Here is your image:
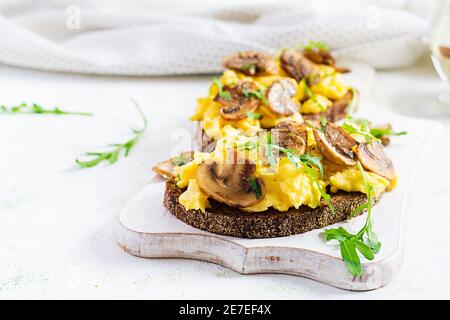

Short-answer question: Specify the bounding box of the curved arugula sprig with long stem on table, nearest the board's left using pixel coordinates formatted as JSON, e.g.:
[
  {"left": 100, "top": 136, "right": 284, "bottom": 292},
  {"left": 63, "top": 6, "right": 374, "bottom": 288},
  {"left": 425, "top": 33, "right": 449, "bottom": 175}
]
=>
[{"left": 76, "top": 99, "right": 147, "bottom": 168}]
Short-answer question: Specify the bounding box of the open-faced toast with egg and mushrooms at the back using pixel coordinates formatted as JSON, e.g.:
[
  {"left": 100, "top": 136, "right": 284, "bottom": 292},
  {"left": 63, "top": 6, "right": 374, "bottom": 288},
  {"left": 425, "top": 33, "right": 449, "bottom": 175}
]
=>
[{"left": 191, "top": 42, "right": 356, "bottom": 150}]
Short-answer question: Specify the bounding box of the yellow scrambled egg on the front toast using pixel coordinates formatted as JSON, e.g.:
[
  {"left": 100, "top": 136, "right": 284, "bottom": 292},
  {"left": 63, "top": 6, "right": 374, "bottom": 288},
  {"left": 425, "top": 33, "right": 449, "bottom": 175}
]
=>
[{"left": 175, "top": 132, "right": 396, "bottom": 212}]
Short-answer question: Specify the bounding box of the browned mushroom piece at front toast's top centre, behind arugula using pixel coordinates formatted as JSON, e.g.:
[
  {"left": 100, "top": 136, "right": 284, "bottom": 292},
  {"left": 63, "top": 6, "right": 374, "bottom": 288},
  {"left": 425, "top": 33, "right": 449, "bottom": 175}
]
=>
[{"left": 272, "top": 121, "right": 308, "bottom": 155}]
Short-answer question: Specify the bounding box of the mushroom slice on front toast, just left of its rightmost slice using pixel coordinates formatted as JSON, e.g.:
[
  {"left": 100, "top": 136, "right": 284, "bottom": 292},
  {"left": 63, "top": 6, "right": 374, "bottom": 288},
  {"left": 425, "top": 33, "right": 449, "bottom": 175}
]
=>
[{"left": 313, "top": 123, "right": 357, "bottom": 166}]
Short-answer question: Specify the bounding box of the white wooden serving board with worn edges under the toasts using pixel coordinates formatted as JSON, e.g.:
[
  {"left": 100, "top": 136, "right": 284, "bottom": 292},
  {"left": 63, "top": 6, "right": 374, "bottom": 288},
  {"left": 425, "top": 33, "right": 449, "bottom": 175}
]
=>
[{"left": 115, "top": 62, "right": 440, "bottom": 291}]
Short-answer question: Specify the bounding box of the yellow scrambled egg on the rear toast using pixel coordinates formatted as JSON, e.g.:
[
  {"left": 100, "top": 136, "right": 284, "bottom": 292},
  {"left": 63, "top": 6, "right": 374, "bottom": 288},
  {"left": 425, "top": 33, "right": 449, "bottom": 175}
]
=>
[{"left": 190, "top": 65, "right": 350, "bottom": 140}]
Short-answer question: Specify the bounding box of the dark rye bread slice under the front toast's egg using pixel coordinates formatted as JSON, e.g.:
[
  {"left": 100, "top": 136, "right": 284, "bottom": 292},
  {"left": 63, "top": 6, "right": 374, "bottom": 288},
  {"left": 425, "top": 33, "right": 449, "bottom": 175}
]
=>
[{"left": 164, "top": 181, "right": 378, "bottom": 239}]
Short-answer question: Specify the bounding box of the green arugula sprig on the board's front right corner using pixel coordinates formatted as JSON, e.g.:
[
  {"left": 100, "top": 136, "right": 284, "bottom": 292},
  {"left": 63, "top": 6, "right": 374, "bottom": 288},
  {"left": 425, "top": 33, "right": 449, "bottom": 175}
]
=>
[{"left": 324, "top": 162, "right": 381, "bottom": 277}]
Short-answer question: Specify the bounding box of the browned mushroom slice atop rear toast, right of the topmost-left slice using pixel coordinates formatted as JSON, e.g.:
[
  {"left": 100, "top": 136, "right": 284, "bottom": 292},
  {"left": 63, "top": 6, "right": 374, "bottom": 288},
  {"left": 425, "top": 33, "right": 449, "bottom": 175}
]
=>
[{"left": 280, "top": 49, "right": 319, "bottom": 84}]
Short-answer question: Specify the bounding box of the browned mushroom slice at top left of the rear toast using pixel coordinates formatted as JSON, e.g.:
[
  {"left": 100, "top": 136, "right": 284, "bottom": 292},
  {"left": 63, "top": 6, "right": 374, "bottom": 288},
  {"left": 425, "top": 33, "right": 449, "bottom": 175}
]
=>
[{"left": 223, "top": 51, "right": 278, "bottom": 76}]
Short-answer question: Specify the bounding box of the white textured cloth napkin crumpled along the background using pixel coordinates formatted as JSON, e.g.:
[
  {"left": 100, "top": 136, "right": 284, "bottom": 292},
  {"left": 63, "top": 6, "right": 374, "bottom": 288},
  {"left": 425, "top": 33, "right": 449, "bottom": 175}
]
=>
[{"left": 0, "top": 0, "right": 428, "bottom": 75}]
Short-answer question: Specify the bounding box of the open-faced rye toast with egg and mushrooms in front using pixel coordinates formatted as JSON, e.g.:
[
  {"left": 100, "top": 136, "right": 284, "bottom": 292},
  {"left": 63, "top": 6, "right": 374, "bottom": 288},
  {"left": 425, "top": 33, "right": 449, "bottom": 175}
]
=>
[{"left": 154, "top": 118, "right": 396, "bottom": 238}]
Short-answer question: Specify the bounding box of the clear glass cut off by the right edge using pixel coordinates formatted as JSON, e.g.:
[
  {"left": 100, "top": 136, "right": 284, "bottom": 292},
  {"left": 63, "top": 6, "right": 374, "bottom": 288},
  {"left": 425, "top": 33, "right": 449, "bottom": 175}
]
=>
[{"left": 430, "top": 0, "right": 450, "bottom": 109}]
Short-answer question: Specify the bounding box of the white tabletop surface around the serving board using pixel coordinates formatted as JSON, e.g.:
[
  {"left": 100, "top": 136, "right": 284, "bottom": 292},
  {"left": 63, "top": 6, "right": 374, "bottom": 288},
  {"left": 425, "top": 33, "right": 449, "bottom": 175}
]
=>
[{"left": 0, "top": 59, "right": 450, "bottom": 299}]
